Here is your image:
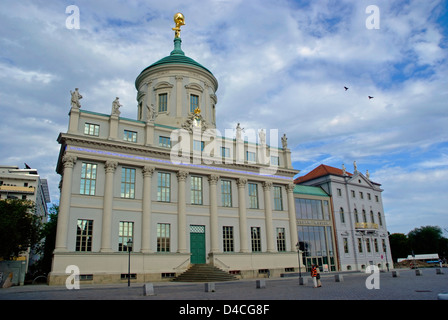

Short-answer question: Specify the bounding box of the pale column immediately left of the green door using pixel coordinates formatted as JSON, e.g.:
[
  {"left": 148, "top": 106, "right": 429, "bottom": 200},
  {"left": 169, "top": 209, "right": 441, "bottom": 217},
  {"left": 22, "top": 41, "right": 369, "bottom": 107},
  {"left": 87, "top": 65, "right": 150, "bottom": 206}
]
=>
[{"left": 176, "top": 171, "right": 188, "bottom": 253}]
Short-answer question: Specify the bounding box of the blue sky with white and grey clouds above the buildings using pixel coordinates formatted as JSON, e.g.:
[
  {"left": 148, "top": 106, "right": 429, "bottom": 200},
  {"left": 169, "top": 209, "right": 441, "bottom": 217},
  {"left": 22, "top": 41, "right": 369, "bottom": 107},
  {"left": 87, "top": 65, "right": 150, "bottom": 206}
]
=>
[{"left": 0, "top": 0, "right": 448, "bottom": 236}]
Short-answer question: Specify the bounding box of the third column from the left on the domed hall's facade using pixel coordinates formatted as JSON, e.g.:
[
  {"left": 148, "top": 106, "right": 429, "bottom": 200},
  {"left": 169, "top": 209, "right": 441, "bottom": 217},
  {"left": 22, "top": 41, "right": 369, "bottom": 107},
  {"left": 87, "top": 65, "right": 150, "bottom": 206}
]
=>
[{"left": 141, "top": 166, "right": 154, "bottom": 253}]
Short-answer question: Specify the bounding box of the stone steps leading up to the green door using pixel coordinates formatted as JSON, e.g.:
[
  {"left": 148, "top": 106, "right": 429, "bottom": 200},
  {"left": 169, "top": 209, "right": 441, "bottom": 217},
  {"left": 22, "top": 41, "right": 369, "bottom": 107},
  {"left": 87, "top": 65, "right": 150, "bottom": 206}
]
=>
[{"left": 173, "top": 264, "right": 238, "bottom": 282}]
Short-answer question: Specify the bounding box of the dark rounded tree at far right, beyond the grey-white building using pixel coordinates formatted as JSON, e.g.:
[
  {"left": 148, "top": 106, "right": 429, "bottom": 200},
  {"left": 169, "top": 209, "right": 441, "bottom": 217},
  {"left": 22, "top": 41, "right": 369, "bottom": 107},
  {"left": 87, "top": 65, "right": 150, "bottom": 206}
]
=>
[{"left": 408, "top": 226, "right": 444, "bottom": 254}]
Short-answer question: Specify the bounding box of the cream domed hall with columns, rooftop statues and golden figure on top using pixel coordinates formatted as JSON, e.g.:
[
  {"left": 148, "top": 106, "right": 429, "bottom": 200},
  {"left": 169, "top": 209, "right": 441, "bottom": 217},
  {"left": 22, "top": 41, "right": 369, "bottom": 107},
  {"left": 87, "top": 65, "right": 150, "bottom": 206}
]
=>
[{"left": 50, "top": 14, "right": 299, "bottom": 284}]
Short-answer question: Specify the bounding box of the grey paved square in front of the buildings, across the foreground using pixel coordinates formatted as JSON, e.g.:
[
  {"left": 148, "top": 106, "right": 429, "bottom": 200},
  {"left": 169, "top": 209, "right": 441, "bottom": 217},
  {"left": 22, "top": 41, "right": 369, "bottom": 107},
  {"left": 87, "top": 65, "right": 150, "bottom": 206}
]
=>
[{"left": 0, "top": 268, "right": 448, "bottom": 301}]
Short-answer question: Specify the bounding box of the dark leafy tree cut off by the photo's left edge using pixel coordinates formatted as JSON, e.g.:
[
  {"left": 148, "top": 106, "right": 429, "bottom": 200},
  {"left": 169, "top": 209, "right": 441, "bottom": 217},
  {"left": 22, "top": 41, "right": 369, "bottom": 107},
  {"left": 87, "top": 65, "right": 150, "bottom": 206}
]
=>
[{"left": 0, "top": 199, "right": 42, "bottom": 260}]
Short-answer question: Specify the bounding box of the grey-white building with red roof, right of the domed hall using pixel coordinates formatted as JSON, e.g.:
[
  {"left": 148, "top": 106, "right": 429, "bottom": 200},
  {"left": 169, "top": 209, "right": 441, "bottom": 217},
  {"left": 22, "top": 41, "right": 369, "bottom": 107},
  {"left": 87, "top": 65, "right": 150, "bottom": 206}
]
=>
[{"left": 295, "top": 163, "right": 393, "bottom": 271}]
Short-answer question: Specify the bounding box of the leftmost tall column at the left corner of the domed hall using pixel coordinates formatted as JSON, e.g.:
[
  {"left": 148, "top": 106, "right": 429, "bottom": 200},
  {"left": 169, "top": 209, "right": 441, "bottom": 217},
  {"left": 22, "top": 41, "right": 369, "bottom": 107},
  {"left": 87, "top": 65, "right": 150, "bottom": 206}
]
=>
[{"left": 54, "top": 154, "right": 76, "bottom": 252}]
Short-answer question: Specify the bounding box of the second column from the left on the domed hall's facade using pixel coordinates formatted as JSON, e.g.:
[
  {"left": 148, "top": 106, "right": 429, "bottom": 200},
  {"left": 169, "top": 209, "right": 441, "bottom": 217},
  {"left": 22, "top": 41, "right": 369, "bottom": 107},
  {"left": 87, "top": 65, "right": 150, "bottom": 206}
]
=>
[{"left": 100, "top": 161, "right": 118, "bottom": 252}]
